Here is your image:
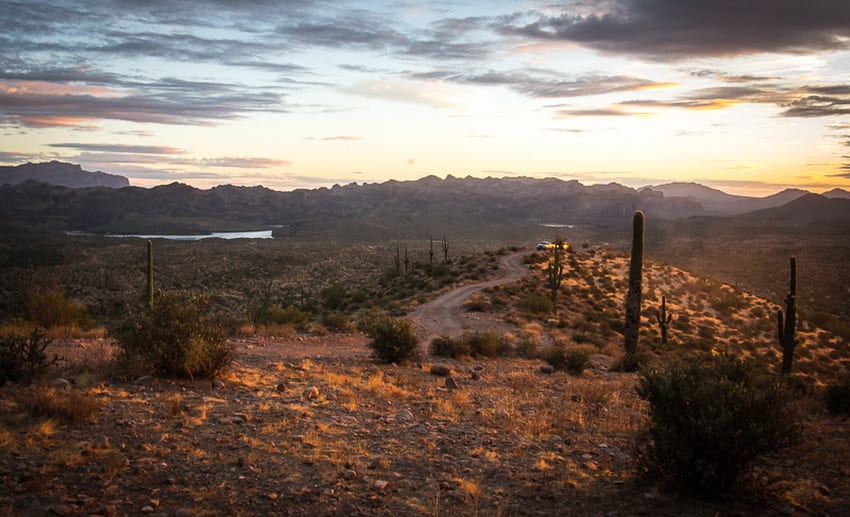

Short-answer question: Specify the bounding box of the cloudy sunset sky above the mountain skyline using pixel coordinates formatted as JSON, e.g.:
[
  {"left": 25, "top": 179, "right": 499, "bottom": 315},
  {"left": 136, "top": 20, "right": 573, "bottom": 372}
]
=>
[{"left": 0, "top": 0, "right": 850, "bottom": 195}]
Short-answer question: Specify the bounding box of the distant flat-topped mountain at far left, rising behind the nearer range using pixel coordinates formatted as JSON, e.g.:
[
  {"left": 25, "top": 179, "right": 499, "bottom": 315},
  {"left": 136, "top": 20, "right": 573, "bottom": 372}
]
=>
[{"left": 0, "top": 160, "right": 130, "bottom": 188}]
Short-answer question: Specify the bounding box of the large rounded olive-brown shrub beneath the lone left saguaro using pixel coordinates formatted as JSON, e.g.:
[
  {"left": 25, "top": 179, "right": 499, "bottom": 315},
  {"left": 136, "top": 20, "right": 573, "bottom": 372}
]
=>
[{"left": 111, "top": 292, "right": 233, "bottom": 378}]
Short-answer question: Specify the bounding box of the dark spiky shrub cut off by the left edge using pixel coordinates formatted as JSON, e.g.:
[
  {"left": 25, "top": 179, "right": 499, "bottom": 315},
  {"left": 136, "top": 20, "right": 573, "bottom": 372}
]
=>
[{"left": 0, "top": 331, "right": 59, "bottom": 383}]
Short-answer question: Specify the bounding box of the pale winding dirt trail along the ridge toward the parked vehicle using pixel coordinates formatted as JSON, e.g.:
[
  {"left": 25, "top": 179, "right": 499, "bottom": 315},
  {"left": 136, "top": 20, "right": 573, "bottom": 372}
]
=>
[{"left": 409, "top": 251, "right": 529, "bottom": 343}]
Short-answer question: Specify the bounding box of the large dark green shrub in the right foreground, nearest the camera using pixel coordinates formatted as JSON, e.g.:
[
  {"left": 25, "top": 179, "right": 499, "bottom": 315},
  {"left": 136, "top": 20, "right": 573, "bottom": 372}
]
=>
[{"left": 638, "top": 355, "right": 799, "bottom": 494}]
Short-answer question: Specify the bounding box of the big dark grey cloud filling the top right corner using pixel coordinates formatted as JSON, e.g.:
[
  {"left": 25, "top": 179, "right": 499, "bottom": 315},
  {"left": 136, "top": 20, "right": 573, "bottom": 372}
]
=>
[{"left": 501, "top": 0, "right": 850, "bottom": 60}]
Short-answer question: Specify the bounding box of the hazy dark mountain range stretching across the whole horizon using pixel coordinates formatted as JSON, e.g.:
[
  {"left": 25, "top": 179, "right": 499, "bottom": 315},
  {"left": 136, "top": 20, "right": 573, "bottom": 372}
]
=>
[{"left": 0, "top": 162, "right": 850, "bottom": 238}]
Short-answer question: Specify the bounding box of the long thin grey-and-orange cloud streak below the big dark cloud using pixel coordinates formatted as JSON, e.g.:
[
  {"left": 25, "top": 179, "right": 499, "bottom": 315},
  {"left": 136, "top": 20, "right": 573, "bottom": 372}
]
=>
[{"left": 412, "top": 70, "right": 672, "bottom": 98}]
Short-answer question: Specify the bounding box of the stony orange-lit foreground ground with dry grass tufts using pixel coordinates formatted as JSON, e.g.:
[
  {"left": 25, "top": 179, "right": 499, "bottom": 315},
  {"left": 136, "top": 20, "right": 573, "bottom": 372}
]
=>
[{"left": 0, "top": 335, "right": 850, "bottom": 516}]
